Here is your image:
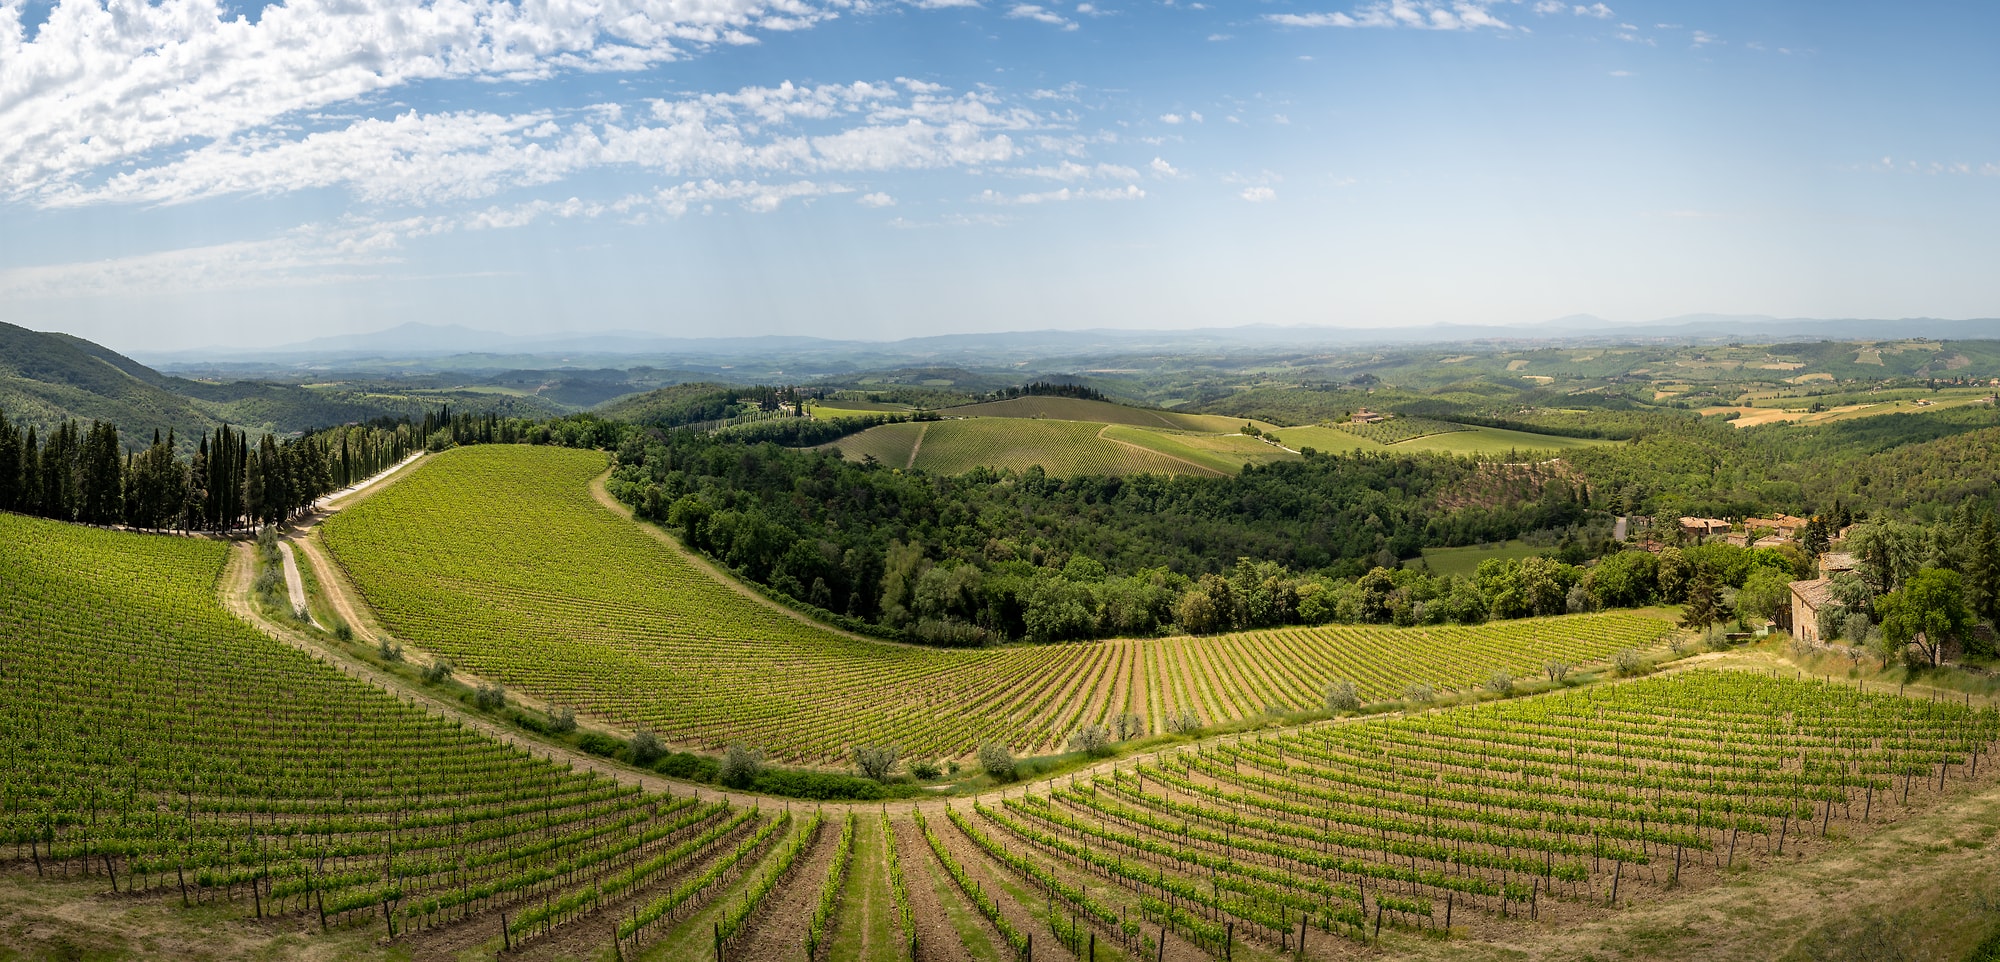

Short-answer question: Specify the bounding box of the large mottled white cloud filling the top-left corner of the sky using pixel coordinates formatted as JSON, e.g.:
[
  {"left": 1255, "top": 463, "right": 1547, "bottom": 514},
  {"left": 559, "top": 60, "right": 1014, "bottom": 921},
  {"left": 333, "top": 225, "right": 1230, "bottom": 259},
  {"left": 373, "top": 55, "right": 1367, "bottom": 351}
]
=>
[{"left": 0, "top": 0, "right": 846, "bottom": 198}]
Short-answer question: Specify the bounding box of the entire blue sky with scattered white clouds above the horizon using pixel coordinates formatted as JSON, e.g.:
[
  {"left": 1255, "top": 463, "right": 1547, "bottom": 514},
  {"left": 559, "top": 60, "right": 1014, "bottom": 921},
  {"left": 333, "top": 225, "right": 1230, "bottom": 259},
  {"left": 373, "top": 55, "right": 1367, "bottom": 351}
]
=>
[{"left": 0, "top": 0, "right": 2000, "bottom": 350}]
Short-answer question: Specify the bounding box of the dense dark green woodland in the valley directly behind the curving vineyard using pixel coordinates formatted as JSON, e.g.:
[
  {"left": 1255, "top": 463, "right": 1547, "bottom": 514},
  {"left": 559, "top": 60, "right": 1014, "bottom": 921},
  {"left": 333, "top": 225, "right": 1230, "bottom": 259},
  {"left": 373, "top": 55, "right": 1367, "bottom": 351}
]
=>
[{"left": 610, "top": 430, "right": 1590, "bottom": 644}]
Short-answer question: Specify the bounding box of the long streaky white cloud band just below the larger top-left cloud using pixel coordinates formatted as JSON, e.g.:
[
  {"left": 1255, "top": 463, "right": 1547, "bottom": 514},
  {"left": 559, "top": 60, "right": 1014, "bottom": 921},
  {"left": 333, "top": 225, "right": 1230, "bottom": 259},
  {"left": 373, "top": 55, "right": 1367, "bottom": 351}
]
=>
[{"left": 38, "top": 82, "right": 1056, "bottom": 206}]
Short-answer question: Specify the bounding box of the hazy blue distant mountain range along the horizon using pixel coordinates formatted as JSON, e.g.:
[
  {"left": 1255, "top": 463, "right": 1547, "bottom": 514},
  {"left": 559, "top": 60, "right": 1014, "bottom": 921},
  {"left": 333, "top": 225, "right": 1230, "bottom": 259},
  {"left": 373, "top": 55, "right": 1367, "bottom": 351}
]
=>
[{"left": 142, "top": 314, "right": 2000, "bottom": 370}]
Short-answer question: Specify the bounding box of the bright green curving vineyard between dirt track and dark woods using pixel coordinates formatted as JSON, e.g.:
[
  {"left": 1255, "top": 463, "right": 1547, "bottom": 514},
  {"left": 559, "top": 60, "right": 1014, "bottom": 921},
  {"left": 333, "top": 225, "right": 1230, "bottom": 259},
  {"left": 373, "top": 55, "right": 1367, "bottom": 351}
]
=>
[{"left": 322, "top": 446, "right": 1668, "bottom": 762}]
